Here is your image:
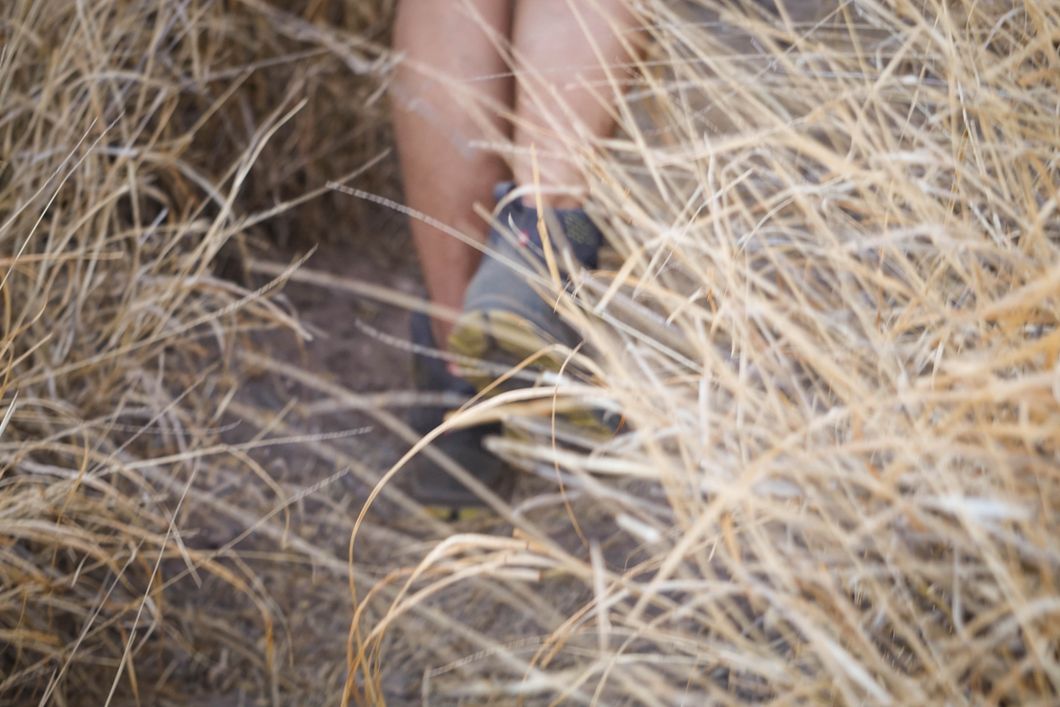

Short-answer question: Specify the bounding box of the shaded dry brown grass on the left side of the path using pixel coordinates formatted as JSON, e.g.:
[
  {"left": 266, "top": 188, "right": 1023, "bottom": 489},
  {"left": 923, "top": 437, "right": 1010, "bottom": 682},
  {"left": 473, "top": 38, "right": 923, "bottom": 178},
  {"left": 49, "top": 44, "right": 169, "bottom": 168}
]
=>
[{"left": 0, "top": 0, "right": 389, "bottom": 705}]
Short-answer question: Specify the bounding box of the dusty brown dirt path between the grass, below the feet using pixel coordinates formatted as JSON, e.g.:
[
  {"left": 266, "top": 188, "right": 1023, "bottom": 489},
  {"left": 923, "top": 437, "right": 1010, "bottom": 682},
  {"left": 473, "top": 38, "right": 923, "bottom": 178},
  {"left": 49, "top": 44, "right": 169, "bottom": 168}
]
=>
[{"left": 178, "top": 199, "right": 555, "bottom": 707}]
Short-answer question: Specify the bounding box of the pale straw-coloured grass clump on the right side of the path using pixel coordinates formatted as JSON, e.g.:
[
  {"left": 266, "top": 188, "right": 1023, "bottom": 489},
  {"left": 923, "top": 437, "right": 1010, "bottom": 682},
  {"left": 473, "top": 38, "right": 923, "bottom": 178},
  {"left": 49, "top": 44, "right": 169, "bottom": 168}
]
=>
[{"left": 351, "top": 0, "right": 1060, "bottom": 705}]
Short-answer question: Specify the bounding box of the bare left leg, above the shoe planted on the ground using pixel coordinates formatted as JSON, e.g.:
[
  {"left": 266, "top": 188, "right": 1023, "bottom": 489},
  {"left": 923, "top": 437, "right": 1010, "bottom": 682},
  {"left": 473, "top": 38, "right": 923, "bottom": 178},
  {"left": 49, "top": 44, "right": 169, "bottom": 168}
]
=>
[{"left": 393, "top": 0, "right": 513, "bottom": 346}]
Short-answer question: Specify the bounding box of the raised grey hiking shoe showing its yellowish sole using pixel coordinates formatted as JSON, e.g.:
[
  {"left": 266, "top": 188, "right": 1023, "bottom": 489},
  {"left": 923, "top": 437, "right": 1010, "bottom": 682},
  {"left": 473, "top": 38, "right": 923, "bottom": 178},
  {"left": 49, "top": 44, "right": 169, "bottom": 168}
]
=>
[{"left": 449, "top": 182, "right": 603, "bottom": 390}]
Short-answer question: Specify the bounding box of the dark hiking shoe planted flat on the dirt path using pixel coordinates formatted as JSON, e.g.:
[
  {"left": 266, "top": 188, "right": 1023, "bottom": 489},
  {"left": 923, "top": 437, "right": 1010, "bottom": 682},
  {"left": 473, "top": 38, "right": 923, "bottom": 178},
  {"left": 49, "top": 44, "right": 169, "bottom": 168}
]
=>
[{"left": 408, "top": 313, "right": 515, "bottom": 520}]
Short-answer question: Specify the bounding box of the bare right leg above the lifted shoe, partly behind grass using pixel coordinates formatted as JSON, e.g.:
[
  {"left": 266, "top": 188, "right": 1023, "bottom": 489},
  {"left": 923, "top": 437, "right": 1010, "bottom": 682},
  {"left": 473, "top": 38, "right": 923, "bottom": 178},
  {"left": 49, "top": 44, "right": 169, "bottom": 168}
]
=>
[{"left": 513, "top": 0, "right": 635, "bottom": 207}]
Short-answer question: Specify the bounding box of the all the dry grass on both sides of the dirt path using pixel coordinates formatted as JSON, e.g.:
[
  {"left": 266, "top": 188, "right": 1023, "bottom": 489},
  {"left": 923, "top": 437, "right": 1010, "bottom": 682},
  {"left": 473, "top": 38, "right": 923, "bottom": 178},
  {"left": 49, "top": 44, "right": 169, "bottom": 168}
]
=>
[{"left": 0, "top": 0, "right": 1060, "bottom": 705}]
